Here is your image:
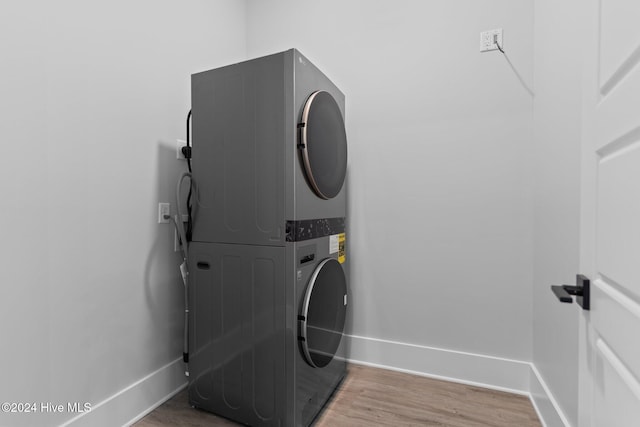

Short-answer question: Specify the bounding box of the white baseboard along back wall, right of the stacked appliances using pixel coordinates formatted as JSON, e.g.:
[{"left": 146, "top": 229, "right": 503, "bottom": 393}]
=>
[{"left": 346, "top": 335, "right": 531, "bottom": 395}]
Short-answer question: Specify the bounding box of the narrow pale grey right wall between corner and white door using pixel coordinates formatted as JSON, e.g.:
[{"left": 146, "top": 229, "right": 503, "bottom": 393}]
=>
[{"left": 533, "top": 0, "right": 582, "bottom": 426}]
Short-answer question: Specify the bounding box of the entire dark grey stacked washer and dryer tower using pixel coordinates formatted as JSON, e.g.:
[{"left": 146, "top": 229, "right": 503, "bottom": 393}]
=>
[{"left": 189, "top": 49, "right": 349, "bottom": 426}]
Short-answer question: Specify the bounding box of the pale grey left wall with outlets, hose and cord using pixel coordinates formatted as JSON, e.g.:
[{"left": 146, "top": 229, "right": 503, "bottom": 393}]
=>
[{"left": 0, "top": 0, "right": 246, "bottom": 426}]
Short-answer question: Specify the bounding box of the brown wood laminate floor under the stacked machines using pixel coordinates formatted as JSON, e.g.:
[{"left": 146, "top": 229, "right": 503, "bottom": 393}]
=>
[{"left": 134, "top": 365, "right": 541, "bottom": 427}]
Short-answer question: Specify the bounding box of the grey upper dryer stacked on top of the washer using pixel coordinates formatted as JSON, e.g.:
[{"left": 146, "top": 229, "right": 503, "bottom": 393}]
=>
[{"left": 191, "top": 49, "right": 347, "bottom": 245}]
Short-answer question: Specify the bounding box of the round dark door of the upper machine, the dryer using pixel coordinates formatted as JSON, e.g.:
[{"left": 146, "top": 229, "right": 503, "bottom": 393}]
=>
[{"left": 298, "top": 90, "right": 347, "bottom": 199}]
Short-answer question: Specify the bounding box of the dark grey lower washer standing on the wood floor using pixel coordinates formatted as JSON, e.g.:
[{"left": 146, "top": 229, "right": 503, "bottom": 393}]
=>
[{"left": 189, "top": 236, "right": 348, "bottom": 426}]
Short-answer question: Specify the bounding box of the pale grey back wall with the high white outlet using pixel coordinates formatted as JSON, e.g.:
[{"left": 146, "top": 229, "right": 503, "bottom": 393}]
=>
[{"left": 247, "top": 0, "right": 533, "bottom": 373}]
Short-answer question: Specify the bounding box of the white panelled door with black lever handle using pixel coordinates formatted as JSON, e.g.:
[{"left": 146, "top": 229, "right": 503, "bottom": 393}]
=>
[{"left": 580, "top": 0, "right": 640, "bottom": 427}]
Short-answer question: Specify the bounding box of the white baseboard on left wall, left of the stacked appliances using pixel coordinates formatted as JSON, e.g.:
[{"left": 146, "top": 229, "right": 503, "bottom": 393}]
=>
[{"left": 60, "top": 357, "right": 187, "bottom": 427}]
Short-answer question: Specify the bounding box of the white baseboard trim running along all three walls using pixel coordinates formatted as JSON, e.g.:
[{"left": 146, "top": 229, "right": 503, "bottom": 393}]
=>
[{"left": 80, "top": 335, "right": 571, "bottom": 427}]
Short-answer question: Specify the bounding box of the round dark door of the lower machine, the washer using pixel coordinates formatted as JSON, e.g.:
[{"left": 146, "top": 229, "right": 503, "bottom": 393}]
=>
[{"left": 299, "top": 258, "right": 347, "bottom": 368}]
